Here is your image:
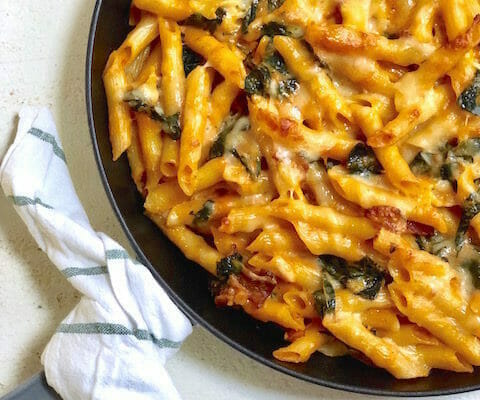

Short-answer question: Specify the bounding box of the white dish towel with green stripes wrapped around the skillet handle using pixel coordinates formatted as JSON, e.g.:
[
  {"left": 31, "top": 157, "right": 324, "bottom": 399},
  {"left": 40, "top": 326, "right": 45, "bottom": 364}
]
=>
[{"left": 0, "top": 108, "right": 192, "bottom": 400}]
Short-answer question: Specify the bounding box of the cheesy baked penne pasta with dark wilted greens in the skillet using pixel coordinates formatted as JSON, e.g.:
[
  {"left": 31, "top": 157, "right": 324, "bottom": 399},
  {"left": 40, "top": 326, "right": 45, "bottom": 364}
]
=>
[{"left": 104, "top": 0, "right": 480, "bottom": 379}]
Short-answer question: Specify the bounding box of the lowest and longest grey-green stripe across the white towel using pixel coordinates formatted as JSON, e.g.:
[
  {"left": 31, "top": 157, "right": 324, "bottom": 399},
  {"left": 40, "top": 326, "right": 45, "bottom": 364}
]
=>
[{"left": 57, "top": 322, "right": 182, "bottom": 349}]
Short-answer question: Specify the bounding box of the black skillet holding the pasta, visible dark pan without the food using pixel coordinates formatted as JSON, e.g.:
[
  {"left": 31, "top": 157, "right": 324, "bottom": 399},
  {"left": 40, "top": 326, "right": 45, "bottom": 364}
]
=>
[{"left": 86, "top": 0, "right": 480, "bottom": 396}]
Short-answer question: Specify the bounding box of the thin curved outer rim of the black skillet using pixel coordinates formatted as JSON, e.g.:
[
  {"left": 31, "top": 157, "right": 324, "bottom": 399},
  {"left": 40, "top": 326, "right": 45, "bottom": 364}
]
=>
[{"left": 85, "top": 0, "right": 480, "bottom": 397}]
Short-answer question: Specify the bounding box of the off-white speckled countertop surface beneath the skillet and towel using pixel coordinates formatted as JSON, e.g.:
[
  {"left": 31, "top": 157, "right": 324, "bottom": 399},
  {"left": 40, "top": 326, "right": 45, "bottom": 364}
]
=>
[{"left": 0, "top": 0, "right": 480, "bottom": 400}]
